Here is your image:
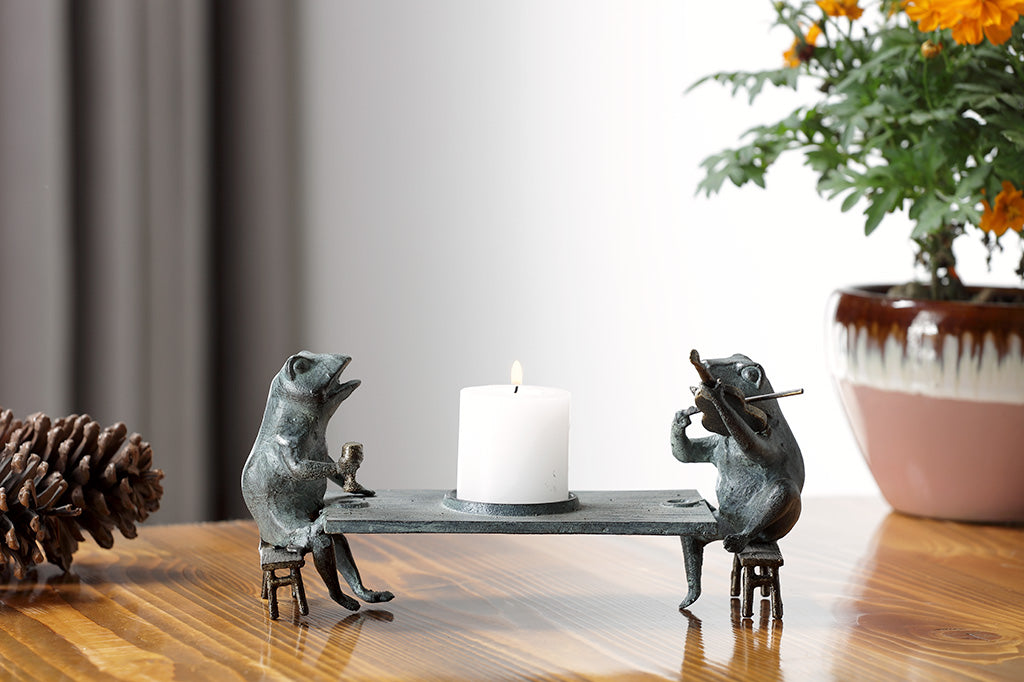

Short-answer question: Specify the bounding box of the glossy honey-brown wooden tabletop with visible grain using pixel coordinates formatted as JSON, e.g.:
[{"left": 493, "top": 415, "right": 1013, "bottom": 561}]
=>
[{"left": 0, "top": 499, "right": 1024, "bottom": 682}]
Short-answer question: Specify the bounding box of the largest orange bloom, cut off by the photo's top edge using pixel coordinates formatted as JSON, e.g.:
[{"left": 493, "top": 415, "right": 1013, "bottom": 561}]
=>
[{"left": 906, "top": 0, "right": 1024, "bottom": 45}]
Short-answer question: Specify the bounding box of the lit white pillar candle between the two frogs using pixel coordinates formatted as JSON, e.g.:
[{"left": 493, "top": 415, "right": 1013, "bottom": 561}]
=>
[{"left": 456, "top": 363, "right": 569, "bottom": 504}]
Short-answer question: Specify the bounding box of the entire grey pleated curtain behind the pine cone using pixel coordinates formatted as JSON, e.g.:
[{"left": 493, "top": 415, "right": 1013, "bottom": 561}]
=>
[{"left": 0, "top": 0, "right": 301, "bottom": 522}]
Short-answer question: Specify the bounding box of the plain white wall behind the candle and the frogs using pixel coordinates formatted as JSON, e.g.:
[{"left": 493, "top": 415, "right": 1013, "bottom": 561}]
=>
[{"left": 301, "top": 0, "right": 1012, "bottom": 497}]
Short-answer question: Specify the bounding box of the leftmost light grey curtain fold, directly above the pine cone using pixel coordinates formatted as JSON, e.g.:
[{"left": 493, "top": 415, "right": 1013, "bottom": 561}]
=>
[{"left": 0, "top": 0, "right": 72, "bottom": 415}]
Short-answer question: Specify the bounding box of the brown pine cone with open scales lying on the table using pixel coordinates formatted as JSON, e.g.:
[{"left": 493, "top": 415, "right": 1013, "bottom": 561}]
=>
[{"left": 0, "top": 410, "right": 164, "bottom": 579}]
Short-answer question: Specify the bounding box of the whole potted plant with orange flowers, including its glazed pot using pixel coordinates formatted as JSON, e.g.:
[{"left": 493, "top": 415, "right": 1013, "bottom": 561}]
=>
[{"left": 695, "top": 0, "right": 1024, "bottom": 521}]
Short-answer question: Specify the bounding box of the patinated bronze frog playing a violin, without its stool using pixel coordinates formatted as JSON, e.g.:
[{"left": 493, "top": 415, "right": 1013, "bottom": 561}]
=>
[{"left": 672, "top": 350, "right": 804, "bottom": 612}]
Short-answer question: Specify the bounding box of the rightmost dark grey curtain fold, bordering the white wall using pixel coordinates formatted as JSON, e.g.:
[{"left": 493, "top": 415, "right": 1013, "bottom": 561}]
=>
[{"left": 210, "top": 0, "right": 302, "bottom": 518}]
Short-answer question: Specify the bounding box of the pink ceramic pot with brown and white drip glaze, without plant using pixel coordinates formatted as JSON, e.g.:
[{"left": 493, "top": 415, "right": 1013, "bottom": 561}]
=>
[{"left": 829, "top": 287, "right": 1024, "bottom": 522}]
